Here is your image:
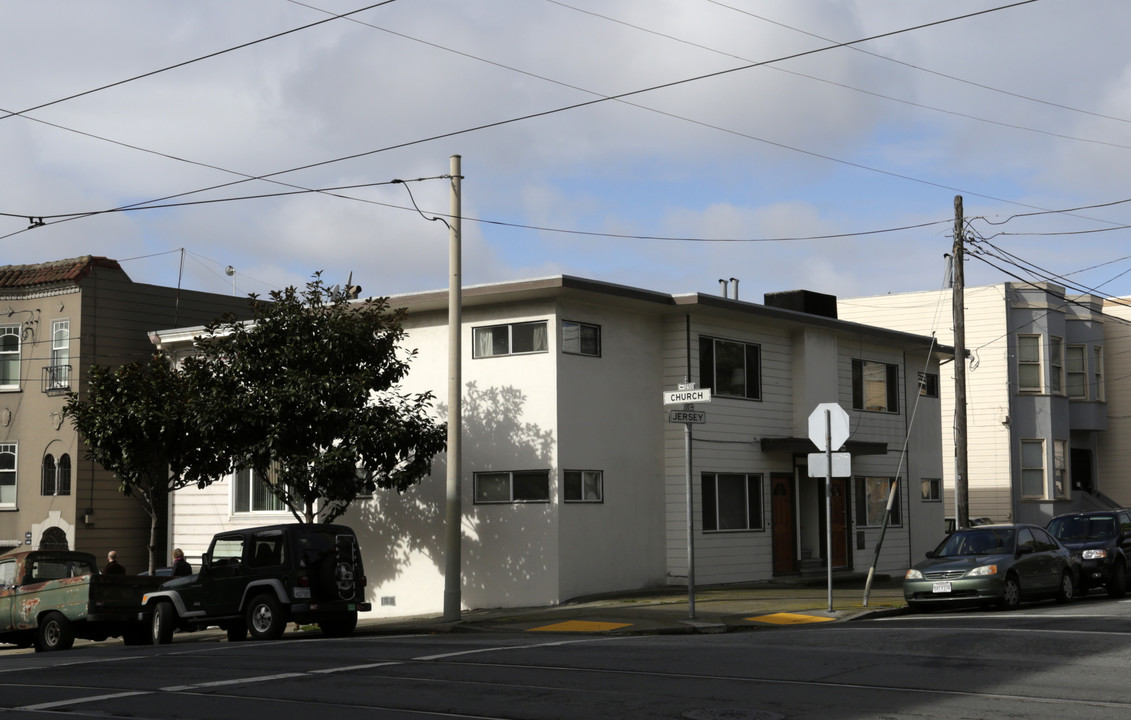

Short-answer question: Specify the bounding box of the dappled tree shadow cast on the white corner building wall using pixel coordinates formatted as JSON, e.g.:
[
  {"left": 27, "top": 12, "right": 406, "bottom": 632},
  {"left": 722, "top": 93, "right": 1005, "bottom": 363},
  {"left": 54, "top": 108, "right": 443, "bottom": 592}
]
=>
[{"left": 343, "top": 382, "right": 558, "bottom": 608}]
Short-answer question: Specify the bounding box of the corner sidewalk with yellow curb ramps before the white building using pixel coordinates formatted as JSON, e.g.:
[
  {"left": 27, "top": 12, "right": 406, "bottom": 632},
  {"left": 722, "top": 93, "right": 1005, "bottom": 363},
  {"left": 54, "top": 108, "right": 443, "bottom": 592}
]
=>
[{"left": 357, "top": 574, "right": 906, "bottom": 634}]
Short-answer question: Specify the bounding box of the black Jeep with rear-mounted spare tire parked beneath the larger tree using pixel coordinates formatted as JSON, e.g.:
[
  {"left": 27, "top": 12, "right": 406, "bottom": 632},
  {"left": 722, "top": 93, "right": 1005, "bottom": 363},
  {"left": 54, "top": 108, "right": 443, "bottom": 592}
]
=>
[{"left": 141, "top": 524, "right": 371, "bottom": 644}]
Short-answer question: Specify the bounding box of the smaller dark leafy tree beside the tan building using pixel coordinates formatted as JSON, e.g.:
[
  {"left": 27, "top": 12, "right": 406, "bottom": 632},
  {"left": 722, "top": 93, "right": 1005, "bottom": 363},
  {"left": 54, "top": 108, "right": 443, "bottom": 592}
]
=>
[{"left": 63, "top": 353, "right": 231, "bottom": 573}]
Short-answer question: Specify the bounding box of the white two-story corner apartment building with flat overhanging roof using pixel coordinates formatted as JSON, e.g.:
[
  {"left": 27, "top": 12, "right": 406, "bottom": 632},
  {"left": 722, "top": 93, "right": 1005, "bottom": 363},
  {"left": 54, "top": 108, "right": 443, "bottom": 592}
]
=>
[{"left": 154, "top": 277, "right": 952, "bottom": 615}]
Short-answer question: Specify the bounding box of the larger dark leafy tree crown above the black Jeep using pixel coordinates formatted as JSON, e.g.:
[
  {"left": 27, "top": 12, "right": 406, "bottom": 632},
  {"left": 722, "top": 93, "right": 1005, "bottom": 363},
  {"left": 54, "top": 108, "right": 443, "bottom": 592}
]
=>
[{"left": 184, "top": 274, "right": 446, "bottom": 522}]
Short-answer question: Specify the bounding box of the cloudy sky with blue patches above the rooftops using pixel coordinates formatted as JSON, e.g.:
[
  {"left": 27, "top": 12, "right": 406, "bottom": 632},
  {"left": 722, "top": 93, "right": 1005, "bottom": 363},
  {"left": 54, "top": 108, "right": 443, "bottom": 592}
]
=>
[{"left": 0, "top": 0, "right": 1131, "bottom": 302}]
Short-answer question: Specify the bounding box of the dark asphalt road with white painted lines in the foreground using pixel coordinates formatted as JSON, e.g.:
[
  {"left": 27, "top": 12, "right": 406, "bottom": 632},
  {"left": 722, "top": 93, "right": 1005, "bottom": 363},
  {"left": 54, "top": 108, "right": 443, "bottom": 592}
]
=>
[{"left": 0, "top": 598, "right": 1131, "bottom": 720}]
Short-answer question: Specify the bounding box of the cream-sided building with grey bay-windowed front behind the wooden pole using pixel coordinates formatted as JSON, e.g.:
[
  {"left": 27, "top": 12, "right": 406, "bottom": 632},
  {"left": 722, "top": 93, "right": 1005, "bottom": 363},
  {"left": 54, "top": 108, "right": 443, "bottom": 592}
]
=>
[{"left": 837, "top": 283, "right": 1121, "bottom": 524}]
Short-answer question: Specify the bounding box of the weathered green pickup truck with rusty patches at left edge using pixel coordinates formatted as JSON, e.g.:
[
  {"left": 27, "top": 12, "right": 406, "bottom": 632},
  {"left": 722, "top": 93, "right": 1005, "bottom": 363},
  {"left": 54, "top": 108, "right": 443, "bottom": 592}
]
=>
[{"left": 0, "top": 550, "right": 167, "bottom": 652}]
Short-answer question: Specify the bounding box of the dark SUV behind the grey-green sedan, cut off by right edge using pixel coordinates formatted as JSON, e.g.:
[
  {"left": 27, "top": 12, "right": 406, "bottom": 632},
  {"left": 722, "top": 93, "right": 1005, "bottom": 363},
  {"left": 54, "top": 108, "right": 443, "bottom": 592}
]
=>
[{"left": 1047, "top": 510, "right": 1131, "bottom": 598}]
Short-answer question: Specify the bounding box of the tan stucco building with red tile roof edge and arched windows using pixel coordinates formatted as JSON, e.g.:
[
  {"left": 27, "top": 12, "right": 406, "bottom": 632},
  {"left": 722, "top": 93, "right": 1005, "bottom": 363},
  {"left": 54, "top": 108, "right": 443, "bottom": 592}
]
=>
[{"left": 0, "top": 255, "right": 249, "bottom": 572}]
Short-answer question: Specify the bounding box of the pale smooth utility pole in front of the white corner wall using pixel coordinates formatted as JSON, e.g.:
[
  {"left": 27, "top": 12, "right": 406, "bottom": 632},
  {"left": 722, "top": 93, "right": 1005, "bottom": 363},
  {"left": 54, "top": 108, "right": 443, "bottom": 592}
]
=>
[{"left": 443, "top": 155, "right": 464, "bottom": 623}]
